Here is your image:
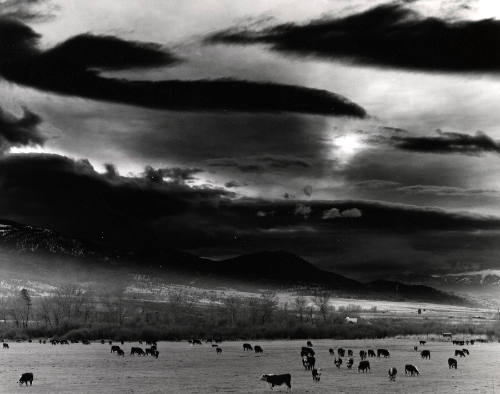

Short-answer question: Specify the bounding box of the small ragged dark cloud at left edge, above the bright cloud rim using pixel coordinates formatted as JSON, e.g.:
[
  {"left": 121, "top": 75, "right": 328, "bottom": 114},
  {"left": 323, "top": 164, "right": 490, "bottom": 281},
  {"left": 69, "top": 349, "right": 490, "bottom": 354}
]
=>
[{"left": 0, "top": 108, "right": 46, "bottom": 153}]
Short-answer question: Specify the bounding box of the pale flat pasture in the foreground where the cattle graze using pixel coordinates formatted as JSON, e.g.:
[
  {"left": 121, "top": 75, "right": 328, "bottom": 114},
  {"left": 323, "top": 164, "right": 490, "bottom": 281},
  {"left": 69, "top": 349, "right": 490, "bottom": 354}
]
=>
[{"left": 0, "top": 339, "right": 500, "bottom": 394}]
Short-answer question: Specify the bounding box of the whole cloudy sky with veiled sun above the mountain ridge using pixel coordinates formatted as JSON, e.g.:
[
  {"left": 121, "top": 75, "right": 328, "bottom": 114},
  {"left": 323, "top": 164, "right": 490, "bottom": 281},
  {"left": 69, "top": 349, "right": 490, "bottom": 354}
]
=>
[{"left": 0, "top": 0, "right": 500, "bottom": 279}]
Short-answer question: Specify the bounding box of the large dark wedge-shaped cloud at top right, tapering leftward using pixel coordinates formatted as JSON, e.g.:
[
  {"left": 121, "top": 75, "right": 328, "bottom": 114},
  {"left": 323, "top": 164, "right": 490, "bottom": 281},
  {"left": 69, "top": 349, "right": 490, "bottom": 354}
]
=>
[{"left": 208, "top": 3, "right": 500, "bottom": 73}]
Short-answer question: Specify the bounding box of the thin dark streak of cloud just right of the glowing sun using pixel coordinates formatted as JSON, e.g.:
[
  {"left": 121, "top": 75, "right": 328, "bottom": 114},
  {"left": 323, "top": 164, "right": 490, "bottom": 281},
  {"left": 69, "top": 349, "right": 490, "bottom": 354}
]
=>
[{"left": 390, "top": 130, "right": 500, "bottom": 155}]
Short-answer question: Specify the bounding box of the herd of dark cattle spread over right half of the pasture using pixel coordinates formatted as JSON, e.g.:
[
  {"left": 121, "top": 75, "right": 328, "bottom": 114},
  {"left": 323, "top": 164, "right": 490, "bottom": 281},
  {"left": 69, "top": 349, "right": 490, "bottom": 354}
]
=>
[{"left": 258, "top": 340, "right": 475, "bottom": 389}]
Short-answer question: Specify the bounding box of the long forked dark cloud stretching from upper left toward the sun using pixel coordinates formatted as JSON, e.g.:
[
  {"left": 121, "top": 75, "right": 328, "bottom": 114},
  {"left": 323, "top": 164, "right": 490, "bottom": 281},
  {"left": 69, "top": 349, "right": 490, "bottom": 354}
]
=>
[{"left": 0, "top": 20, "right": 366, "bottom": 118}]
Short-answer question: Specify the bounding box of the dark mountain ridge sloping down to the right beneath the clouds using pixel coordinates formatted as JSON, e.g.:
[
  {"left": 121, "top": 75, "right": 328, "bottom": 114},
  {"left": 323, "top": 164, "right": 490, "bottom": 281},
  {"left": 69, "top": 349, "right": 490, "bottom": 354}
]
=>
[{"left": 0, "top": 221, "right": 466, "bottom": 304}]
